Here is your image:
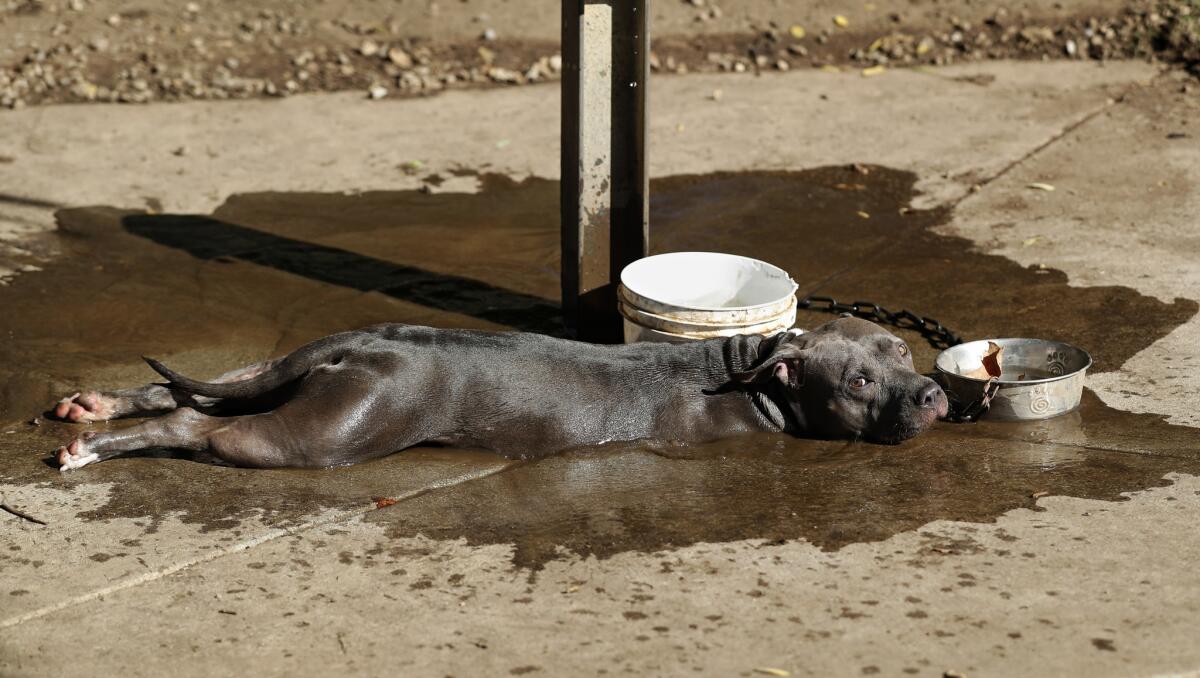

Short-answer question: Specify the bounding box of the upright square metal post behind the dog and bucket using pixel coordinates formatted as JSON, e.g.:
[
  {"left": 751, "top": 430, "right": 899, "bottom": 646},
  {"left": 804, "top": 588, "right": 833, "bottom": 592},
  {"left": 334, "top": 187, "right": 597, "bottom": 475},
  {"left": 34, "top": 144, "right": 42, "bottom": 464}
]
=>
[{"left": 560, "top": 0, "right": 650, "bottom": 342}]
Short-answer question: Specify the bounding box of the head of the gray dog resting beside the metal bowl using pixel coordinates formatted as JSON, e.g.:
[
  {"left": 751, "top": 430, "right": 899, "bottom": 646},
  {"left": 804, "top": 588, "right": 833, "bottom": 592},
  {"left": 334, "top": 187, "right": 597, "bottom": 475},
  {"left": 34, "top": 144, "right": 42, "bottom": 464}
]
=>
[{"left": 734, "top": 317, "right": 948, "bottom": 443}]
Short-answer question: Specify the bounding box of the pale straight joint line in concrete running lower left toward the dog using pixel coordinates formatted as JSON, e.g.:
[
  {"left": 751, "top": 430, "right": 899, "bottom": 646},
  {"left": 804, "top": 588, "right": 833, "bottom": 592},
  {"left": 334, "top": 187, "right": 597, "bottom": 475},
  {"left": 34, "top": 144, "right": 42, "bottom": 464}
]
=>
[{"left": 0, "top": 461, "right": 523, "bottom": 629}]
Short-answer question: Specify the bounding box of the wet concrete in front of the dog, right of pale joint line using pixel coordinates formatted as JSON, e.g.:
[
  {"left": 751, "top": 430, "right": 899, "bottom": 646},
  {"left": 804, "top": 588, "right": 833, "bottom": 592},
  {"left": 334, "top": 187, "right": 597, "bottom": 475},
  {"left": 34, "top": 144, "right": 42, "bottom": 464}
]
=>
[{"left": 379, "top": 394, "right": 1200, "bottom": 569}]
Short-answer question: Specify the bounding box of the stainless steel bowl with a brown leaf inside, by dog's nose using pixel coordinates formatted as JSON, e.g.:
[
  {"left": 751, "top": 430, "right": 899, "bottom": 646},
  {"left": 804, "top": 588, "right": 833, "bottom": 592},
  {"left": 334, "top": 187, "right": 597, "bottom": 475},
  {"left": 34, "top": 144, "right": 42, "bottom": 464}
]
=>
[{"left": 934, "top": 338, "right": 1092, "bottom": 420}]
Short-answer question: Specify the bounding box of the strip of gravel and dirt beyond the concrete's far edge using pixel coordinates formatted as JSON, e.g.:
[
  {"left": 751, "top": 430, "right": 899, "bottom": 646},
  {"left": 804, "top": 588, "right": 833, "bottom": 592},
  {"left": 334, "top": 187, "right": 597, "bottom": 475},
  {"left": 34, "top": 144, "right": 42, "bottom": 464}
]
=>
[{"left": 0, "top": 0, "right": 1200, "bottom": 108}]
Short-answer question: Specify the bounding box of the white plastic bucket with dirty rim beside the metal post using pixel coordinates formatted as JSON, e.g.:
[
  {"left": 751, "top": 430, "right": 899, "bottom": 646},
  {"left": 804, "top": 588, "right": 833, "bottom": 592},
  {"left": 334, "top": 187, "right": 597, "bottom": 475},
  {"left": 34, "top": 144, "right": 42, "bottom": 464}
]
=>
[{"left": 618, "top": 252, "right": 797, "bottom": 343}]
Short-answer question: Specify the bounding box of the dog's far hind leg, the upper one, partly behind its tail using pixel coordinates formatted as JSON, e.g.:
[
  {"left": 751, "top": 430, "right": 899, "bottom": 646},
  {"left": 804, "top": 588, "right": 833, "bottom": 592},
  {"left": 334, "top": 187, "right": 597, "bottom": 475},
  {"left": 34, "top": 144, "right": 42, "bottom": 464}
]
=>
[{"left": 53, "top": 360, "right": 278, "bottom": 421}]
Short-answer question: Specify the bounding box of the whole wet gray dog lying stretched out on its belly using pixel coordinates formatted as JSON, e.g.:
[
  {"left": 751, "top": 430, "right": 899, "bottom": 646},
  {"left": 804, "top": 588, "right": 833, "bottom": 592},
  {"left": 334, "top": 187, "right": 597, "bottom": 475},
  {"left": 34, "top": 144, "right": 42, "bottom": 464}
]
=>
[{"left": 54, "top": 318, "right": 947, "bottom": 470}]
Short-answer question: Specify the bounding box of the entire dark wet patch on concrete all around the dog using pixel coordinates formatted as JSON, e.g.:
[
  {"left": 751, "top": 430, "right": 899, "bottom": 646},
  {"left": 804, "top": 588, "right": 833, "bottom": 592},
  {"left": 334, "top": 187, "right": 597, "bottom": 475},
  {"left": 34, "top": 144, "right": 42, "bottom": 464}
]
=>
[{"left": 0, "top": 167, "right": 1200, "bottom": 556}]
